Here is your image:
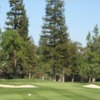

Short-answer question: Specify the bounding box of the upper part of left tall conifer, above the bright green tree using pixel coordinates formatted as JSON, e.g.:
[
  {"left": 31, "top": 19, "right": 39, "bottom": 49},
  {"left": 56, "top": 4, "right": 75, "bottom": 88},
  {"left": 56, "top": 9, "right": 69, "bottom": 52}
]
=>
[{"left": 6, "top": 0, "right": 28, "bottom": 39}]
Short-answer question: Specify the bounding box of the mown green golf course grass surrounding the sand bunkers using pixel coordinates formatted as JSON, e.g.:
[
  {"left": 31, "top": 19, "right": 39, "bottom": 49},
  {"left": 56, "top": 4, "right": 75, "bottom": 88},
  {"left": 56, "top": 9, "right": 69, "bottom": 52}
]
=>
[{"left": 0, "top": 80, "right": 100, "bottom": 100}]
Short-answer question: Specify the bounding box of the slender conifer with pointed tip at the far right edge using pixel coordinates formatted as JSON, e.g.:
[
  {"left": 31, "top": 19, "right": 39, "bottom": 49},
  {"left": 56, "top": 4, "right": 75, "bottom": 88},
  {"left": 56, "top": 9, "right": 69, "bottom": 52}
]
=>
[{"left": 91, "top": 25, "right": 100, "bottom": 82}]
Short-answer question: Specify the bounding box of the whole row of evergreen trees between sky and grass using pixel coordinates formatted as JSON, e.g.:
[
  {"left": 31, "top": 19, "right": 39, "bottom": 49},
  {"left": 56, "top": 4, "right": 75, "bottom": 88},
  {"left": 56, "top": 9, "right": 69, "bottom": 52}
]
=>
[{"left": 0, "top": 0, "right": 100, "bottom": 82}]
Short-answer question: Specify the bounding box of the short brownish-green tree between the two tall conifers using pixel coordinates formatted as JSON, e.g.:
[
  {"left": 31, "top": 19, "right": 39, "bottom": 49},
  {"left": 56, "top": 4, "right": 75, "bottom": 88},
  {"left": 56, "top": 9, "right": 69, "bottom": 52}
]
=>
[{"left": 24, "top": 38, "right": 36, "bottom": 79}]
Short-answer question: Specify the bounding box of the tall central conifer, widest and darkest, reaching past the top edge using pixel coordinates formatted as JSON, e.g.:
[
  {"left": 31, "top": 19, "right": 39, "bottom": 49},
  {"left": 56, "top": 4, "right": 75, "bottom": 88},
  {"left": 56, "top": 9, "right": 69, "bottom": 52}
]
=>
[{"left": 40, "top": 0, "right": 69, "bottom": 79}]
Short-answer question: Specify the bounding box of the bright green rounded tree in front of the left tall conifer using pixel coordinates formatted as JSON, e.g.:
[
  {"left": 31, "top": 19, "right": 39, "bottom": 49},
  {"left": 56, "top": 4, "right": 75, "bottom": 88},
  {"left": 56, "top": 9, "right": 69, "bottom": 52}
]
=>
[{"left": 0, "top": 30, "right": 24, "bottom": 78}]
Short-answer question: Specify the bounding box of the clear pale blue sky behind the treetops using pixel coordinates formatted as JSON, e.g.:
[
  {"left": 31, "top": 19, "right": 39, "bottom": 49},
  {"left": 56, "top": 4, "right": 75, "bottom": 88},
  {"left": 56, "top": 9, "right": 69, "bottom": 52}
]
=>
[{"left": 0, "top": 0, "right": 100, "bottom": 46}]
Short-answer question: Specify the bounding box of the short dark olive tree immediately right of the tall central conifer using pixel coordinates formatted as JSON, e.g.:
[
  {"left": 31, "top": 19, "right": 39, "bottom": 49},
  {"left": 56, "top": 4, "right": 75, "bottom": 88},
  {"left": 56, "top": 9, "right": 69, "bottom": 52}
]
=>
[{"left": 66, "top": 42, "right": 81, "bottom": 82}]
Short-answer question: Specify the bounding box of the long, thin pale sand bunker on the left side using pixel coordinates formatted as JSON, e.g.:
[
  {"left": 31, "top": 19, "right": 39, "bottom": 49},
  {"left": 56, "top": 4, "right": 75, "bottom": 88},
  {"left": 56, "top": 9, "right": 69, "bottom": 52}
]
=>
[{"left": 0, "top": 84, "right": 36, "bottom": 88}]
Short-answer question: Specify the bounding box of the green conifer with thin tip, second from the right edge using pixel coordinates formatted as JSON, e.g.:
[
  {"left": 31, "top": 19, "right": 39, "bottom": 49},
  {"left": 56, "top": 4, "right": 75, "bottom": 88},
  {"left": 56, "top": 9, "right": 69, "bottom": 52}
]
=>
[{"left": 79, "top": 32, "right": 92, "bottom": 82}]
